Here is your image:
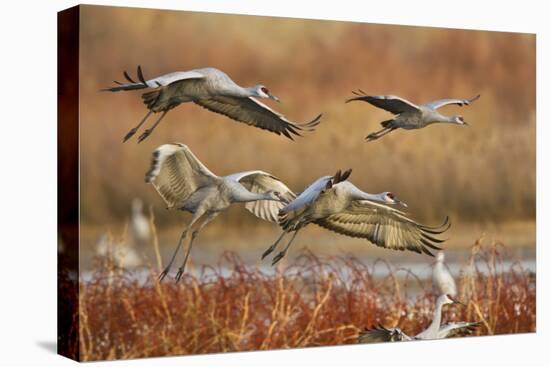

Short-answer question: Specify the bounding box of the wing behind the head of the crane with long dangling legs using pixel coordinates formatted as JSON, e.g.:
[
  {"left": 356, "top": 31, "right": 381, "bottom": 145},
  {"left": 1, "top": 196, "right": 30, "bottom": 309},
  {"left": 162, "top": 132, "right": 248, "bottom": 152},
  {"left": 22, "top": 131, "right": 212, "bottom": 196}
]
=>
[{"left": 225, "top": 171, "right": 296, "bottom": 223}]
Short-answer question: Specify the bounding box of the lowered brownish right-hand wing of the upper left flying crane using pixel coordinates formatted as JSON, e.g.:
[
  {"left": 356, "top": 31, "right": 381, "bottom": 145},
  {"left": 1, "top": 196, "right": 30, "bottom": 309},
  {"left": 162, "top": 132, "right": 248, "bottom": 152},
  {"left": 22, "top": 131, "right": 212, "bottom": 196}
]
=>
[{"left": 194, "top": 96, "right": 321, "bottom": 139}]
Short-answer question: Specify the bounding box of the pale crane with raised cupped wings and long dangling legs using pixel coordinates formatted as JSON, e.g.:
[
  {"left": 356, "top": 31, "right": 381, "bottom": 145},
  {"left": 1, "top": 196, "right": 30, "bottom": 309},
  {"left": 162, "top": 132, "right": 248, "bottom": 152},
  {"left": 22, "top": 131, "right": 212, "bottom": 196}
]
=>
[{"left": 145, "top": 144, "right": 296, "bottom": 281}]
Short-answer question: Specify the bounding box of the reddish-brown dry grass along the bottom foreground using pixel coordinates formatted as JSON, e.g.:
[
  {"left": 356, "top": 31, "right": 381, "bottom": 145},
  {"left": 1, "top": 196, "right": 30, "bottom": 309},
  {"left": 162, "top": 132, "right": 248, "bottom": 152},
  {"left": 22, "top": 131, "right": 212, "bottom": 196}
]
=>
[{"left": 68, "top": 239, "right": 536, "bottom": 361}]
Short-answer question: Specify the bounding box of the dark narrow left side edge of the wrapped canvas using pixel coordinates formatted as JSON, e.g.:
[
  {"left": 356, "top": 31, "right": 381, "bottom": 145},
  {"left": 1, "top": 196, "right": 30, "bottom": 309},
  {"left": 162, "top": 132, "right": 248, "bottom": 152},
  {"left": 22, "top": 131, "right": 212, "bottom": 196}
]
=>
[{"left": 57, "top": 6, "right": 80, "bottom": 360}]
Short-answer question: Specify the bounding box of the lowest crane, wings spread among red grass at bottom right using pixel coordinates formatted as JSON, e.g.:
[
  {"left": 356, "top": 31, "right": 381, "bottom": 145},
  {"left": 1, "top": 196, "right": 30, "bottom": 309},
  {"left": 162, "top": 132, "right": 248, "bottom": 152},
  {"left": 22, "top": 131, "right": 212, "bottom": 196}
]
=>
[{"left": 358, "top": 294, "right": 480, "bottom": 343}]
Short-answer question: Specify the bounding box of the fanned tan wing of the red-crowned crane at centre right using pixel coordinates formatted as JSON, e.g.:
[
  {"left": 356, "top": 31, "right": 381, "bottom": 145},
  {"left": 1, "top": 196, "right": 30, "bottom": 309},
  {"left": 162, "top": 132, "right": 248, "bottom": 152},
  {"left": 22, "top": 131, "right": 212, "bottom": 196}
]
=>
[{"left": 314, "top": 200, "right": 450, "bottom": 256}]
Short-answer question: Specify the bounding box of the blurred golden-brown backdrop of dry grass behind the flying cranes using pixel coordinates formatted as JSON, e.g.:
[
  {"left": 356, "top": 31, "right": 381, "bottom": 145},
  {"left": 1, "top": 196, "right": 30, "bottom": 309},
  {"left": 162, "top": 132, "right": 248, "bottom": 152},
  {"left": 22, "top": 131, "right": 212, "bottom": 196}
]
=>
[{"left": 75, "top": 7, "right": 535, "bottom": 230}]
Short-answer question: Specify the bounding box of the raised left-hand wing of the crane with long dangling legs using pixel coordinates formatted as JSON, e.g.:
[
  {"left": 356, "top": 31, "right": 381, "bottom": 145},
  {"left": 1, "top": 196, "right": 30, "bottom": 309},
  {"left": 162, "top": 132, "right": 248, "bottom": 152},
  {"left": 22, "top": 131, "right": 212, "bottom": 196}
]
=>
[{"left": 145, "top": 144, "right": 220, "bottom": 208}]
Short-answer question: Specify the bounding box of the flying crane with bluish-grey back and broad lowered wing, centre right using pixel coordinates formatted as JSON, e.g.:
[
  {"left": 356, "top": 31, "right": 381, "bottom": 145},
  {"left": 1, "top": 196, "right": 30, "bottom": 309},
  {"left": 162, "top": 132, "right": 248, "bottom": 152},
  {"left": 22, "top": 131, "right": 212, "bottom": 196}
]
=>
[{"left": 262, "top": 170, "right": 450, "bottom": 265}]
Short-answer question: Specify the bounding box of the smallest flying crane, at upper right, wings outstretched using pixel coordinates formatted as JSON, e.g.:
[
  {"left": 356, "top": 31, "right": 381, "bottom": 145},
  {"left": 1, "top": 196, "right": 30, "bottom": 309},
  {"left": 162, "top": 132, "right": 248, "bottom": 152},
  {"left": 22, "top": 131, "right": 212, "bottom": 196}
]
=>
[{"left": 346, "top": 90, "right": 480, "bottom": 141}]
